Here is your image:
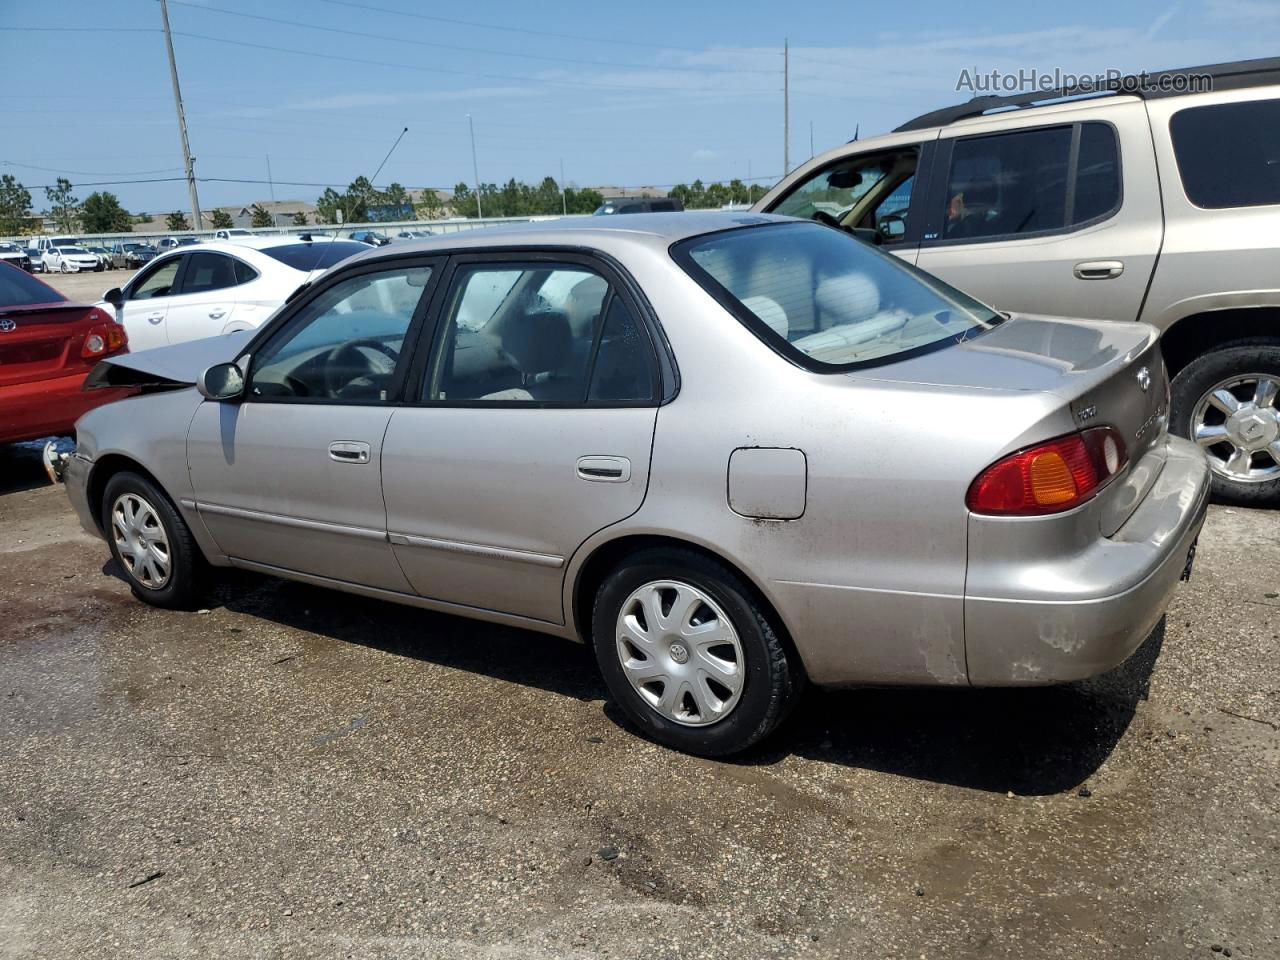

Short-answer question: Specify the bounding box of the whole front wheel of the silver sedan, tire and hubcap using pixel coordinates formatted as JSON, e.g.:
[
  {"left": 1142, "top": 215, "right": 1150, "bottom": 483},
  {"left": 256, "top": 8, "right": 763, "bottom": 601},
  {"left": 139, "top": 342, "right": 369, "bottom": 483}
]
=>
[{"left": 102, "top": 472, "right": 204, "bottom": 609}]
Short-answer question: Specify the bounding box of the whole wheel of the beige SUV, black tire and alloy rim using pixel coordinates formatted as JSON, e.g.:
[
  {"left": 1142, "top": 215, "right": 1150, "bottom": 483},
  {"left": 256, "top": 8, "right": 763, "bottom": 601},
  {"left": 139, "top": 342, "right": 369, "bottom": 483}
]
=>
[{"left": 1169, "top": 343, "right": 1280, "bottom": 507}]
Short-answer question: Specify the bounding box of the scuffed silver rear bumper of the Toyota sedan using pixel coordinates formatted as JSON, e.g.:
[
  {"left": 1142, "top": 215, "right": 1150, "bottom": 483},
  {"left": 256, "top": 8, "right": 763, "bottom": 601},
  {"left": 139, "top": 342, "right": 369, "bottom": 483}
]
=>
[{"left": 964, "top": 436, "right": 1210, "bottom": 686}]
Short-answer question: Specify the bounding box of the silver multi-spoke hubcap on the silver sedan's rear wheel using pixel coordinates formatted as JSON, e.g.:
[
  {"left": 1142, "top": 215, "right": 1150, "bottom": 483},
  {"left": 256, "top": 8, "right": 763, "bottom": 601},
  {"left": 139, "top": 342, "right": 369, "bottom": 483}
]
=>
[{"left": 616, "top": 580, "right": 744, "bottom": 727}]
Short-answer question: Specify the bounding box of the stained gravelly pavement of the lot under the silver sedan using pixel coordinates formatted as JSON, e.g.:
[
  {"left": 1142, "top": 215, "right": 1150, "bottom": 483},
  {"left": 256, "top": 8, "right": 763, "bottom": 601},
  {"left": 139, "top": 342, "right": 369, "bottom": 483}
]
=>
[{"left": 0, "top": 271, "right": 1280, "bottom": 960}]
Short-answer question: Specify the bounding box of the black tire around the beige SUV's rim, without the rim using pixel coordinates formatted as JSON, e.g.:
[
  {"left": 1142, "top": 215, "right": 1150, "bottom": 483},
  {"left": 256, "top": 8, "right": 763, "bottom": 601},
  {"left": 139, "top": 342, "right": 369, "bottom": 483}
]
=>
[{"left": 1169, "top": 340, "right": 1280, "bottom": 507}]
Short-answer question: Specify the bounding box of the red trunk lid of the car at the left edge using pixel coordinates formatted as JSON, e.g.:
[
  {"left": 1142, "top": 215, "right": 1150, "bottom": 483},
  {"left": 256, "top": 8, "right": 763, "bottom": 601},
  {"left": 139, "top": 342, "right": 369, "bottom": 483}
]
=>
[{"left": 0, "top": 302, "right": 108, "bottom": 387}]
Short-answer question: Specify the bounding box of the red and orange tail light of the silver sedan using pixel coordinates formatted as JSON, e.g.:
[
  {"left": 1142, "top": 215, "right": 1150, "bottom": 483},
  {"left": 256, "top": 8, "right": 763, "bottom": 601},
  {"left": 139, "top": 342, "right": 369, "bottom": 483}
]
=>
[{"left": 965, "top": 426, "right": 1129, "bottom": 516}]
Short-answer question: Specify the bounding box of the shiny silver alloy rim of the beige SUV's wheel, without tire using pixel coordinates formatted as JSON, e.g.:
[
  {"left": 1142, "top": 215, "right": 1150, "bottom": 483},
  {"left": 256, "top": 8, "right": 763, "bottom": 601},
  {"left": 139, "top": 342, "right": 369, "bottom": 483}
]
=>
[{"left": 1192, "top": 374, "right": 1280, "bottom": 483}]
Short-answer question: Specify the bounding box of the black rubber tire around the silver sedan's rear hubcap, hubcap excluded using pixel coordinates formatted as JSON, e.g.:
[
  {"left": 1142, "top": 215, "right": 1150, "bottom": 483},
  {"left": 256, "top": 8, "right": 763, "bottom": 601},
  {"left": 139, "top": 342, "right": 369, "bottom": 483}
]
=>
[{"left": 591, "top": 548, "right": 804, "bottom": 756}]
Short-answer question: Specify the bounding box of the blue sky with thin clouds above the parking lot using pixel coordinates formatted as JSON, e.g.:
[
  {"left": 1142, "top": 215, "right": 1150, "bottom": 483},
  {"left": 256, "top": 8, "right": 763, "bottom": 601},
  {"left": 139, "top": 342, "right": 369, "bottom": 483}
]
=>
[{"left": 0, "top": 0, "right": 1280, "bottom": 211}]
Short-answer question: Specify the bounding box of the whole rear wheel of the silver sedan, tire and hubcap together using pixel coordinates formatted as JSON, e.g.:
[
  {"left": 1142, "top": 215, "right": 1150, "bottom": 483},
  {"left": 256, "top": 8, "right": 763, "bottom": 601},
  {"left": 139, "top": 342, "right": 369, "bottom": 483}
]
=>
[{"left": 591, "top": 549, "right": 801, "bottom": 756}]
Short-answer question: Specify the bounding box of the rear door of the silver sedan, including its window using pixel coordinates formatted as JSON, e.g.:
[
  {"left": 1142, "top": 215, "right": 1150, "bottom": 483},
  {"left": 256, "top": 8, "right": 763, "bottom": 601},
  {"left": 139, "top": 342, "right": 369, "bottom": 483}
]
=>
[{"left": 383, "top": 253, "right": 662, "bottom": 623}]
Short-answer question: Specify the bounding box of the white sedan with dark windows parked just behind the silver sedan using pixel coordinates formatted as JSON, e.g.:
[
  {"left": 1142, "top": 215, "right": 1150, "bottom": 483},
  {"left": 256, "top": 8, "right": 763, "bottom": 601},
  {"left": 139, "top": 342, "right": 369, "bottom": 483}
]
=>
[{"left": 99, "top": 234, "right": 369, "bottom": 351}]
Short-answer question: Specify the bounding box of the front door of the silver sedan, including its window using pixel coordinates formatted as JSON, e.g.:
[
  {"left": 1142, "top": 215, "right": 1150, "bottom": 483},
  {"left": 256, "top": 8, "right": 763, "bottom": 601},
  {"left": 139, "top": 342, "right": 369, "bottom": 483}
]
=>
[{"left": 187, "top": 260, "right": 435, "bottom": 593}]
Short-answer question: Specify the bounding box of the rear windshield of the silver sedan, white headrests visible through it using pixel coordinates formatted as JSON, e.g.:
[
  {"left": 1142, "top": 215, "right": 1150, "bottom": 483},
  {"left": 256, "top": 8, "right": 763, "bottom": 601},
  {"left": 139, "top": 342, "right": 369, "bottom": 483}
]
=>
[{"left": 672, "top": 223, "right": 1004, "bottom": 371}]
